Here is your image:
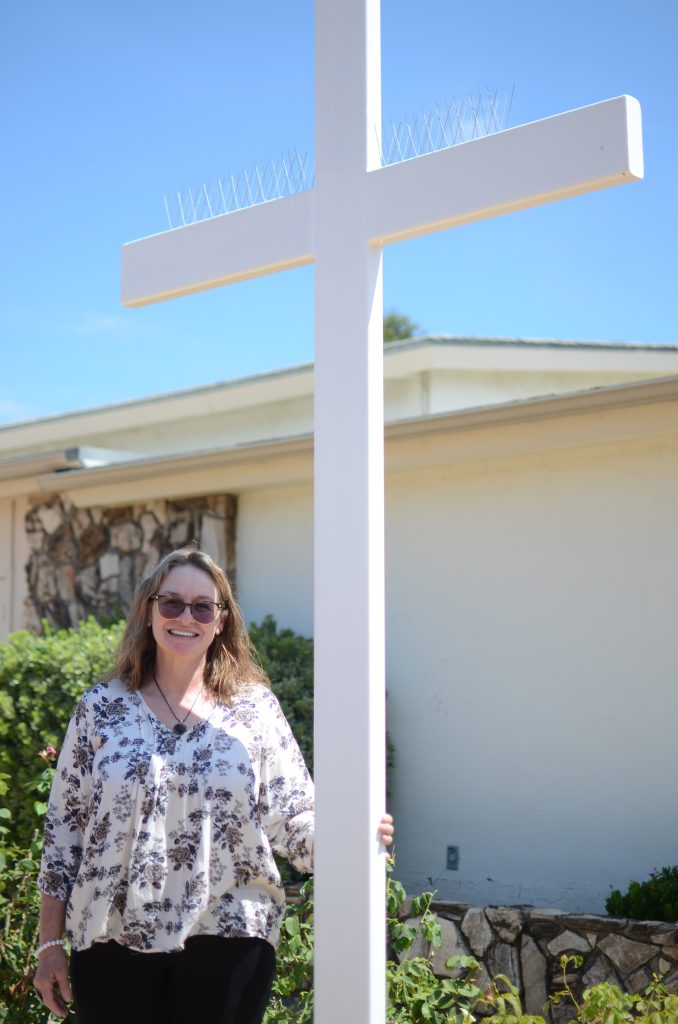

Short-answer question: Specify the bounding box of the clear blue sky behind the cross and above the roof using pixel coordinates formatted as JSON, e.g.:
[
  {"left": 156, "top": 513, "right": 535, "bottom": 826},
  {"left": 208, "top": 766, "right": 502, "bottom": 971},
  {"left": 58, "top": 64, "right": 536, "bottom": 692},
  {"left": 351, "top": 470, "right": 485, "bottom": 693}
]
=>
[{"left": 0, "top": 0, "right": 678, "bottom": 422}]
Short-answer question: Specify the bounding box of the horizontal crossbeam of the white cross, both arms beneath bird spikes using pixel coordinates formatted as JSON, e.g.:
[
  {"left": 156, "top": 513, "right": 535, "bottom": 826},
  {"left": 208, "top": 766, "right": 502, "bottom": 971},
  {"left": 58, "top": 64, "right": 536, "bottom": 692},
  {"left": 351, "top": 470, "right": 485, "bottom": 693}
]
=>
[{"left": 121, "top": 98, "right": 643, "bottom": 306}]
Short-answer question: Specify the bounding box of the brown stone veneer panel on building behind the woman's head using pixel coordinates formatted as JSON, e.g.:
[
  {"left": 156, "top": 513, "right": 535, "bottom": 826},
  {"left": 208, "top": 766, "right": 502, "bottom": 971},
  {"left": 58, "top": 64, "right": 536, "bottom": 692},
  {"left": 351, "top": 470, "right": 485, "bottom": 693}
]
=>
[{"left": 26, "top": 495, "right": 238, "bottom": 631}]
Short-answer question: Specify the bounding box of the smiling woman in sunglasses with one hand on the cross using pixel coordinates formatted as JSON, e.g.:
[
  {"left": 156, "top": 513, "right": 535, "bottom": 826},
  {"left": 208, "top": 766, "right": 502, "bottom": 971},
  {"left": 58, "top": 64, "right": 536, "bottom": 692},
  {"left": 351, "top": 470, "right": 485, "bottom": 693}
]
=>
[{"left": 34, "top": 549, "right": 393, "bottom": 1024}]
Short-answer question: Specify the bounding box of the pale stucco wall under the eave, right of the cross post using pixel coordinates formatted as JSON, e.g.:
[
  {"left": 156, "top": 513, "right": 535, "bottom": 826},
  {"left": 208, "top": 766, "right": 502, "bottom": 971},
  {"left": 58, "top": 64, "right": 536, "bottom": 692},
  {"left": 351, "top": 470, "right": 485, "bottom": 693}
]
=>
[{"left": 387, "top": 439, "right": 678, "bottom": 911}]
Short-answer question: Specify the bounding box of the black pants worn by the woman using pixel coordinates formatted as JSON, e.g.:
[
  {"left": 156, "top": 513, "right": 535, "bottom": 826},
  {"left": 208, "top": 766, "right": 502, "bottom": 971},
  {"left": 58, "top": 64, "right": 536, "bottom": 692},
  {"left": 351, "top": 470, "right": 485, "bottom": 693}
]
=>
[{"left": 71, "top": 935, "right": 276, "bottom": 1024}]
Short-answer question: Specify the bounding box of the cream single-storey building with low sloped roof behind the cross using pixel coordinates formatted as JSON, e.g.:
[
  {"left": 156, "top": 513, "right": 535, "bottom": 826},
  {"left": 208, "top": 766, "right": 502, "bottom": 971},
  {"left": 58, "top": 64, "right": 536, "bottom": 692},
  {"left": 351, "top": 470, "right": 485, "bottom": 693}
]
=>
[{"left": 0, "top": 338, "right": 678, "bottom": 911}]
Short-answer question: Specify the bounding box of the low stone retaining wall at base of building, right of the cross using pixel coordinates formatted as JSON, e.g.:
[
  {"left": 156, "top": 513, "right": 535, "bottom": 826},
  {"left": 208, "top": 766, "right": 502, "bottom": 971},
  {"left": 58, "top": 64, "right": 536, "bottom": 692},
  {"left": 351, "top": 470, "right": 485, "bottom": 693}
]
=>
[{"left": 409, "top": 902, "right": 678, "bottom": 1022}]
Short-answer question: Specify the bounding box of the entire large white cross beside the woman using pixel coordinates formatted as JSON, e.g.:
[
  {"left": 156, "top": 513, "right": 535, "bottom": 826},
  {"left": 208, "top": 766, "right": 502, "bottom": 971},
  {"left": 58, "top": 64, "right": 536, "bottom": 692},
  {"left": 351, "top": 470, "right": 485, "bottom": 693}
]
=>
[{"left": 122, "top": 0, "right": 642, "bottom": 1024}]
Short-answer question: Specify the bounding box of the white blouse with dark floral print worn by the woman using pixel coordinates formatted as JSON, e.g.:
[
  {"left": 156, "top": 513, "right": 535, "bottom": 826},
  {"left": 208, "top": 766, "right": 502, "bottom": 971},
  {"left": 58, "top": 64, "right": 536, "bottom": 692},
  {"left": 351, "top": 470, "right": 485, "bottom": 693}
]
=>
[{"left": 38, "top": 680, "right": 313, "bottom": 951}]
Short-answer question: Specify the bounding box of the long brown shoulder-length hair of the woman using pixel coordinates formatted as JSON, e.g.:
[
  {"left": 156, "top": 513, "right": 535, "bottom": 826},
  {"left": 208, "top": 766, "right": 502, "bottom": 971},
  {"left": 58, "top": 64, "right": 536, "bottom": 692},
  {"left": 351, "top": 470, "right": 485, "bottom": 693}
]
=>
[{"left": 107, "top": 548, "right": 268, "bottom": 701}]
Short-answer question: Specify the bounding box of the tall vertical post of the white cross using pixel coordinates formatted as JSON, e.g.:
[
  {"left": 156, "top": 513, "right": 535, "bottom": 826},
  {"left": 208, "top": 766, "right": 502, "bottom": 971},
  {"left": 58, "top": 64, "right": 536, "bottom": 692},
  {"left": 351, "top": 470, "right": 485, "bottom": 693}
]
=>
[{"left": 314, "top": 0, "right": 385, "bottom": 1024}]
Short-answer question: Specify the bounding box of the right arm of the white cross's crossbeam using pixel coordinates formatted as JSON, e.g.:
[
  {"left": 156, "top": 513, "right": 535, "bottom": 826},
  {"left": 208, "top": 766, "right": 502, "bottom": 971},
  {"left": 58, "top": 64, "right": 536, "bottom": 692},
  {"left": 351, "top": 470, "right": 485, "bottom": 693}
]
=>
[{"left": 368, "top": 96, "right": 643, "bottom": 245}]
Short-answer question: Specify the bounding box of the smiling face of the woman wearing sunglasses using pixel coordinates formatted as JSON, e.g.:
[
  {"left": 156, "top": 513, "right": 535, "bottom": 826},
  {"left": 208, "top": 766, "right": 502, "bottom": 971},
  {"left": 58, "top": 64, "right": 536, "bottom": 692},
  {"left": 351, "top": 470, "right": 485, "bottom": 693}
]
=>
[{"left": 149, "top": 565, "right": 225, "bottom": 660}]
